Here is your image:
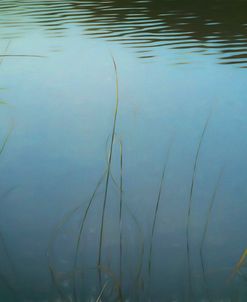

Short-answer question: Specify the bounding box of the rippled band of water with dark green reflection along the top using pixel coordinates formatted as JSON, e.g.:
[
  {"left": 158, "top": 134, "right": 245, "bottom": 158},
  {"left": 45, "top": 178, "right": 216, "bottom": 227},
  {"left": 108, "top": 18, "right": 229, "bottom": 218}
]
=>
[{"left": 0, "top": 0, "right": 247, "bottom": 67}]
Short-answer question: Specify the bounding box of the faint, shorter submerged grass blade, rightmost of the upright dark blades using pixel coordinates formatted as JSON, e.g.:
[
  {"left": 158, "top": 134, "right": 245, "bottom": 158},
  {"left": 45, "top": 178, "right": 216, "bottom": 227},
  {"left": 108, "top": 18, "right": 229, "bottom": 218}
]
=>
[{"left": 200, "top": 169, "right": 223, "bottom": 301}]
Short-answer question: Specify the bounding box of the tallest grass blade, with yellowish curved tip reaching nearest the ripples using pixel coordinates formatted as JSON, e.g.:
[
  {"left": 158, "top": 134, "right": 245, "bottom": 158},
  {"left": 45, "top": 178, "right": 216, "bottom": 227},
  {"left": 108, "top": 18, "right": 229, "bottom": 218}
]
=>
[{"left": 97, "top": 57, "right": 119, "bottom": 284}]
